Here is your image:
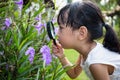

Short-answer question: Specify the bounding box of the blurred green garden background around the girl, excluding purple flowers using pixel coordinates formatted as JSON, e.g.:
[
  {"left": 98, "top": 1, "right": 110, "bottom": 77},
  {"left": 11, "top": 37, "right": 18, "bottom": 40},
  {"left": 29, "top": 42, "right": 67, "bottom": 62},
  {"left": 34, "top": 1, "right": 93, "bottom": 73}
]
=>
[{"left": 0, "top": 0, "right": 120, "bottom": 80}]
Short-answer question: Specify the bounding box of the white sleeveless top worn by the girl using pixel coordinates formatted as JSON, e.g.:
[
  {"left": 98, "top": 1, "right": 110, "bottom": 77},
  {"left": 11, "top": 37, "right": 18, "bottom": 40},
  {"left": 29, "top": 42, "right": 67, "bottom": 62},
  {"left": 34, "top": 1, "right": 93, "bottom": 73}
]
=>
[{"left": 81, "top": 43, "right": 120, "bottom": 80}]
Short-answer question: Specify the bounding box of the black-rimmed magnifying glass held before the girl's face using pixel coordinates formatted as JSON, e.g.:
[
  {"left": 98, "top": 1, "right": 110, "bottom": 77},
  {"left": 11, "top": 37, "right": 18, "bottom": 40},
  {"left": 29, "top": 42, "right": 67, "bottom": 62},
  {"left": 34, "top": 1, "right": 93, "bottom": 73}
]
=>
[{"left": 47, "top": 21, "right": 57, "bottom": 45}]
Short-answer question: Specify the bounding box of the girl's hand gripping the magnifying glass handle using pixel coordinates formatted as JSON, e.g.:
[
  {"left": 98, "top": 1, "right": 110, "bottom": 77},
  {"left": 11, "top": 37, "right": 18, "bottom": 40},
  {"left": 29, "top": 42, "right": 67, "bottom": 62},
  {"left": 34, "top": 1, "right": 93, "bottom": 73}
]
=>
[{"left": 52, "top": 42, "right": 65, "bottom": 59}]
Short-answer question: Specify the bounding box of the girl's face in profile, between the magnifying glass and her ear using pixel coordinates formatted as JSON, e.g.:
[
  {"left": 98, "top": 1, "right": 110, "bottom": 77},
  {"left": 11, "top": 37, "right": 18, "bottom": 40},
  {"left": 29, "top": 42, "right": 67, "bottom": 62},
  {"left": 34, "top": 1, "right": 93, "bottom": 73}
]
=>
[{"left": 58, "top": 25, "right": 77, "bottom": 48}]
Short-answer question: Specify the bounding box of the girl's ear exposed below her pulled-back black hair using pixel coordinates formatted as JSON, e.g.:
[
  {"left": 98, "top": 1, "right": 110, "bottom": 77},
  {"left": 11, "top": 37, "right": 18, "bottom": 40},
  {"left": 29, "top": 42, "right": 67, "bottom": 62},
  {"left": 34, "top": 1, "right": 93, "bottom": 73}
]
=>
[{"left": 79, "top": 26, "right": 88, "bottom": 40}]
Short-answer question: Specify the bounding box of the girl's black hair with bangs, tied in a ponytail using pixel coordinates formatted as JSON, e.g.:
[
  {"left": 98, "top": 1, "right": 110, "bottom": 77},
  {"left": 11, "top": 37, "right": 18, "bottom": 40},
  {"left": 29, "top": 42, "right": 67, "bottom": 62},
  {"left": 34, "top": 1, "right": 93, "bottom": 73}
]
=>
[{"left": 57, "top": 1, "right": 120, "bottom": 53}]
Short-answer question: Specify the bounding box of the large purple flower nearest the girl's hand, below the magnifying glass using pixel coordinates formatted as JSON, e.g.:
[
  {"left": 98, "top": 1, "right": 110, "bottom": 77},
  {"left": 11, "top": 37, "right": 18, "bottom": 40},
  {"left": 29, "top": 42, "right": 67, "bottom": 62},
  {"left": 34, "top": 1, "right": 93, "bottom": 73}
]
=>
[{"left": 40, "top": 45, "right": 52, "bottom": 65}]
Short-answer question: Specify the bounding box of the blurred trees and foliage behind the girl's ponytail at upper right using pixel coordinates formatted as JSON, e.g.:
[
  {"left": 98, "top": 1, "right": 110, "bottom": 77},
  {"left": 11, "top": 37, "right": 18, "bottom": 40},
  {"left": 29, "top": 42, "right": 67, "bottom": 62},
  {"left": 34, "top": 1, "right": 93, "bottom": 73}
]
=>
[{"left": 67, "top": 0, "right": 120, "bottom": 38}]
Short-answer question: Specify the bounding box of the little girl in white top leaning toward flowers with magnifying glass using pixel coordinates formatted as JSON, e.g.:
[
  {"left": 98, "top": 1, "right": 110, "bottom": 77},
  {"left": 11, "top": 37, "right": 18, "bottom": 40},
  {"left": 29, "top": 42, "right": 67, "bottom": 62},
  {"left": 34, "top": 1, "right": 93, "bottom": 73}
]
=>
[{"left": 53, "top": 2, "right": 120, "bottom": 80}]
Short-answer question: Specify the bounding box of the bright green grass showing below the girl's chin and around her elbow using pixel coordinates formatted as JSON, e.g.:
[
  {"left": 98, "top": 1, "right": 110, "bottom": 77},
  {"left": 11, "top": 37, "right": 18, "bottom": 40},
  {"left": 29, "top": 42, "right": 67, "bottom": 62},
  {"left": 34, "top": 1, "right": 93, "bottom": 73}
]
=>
[{"left": 65, "top": 49, "right": 89, "bottom": 80}]
